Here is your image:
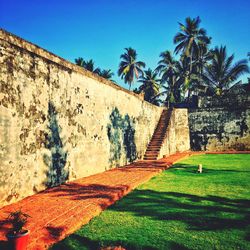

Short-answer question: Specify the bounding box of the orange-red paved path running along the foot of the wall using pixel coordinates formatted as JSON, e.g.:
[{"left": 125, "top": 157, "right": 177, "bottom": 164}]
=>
[{"left": 0, "top": 152, "right": 248, "bottom": 250}]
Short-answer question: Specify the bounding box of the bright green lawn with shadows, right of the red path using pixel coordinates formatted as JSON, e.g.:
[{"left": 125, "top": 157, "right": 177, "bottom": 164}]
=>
[{"left": 52, "top": 154, "right": 250, "bottom": 250}]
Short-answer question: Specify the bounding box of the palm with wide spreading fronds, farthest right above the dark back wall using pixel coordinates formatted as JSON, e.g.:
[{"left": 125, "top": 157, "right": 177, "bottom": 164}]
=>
[{"left": 204, "top": 46, "right": 249, "bottom": 95}]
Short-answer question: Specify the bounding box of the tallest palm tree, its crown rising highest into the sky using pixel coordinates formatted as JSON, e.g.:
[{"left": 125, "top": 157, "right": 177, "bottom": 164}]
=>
[{"left": 174, "top": 17, "right": 211, "bottom": 96}]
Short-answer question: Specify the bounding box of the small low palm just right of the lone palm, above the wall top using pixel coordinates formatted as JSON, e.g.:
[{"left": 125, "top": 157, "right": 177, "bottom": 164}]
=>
[{"left": 138, "top": 68, "right": 160, "bottom": 104}]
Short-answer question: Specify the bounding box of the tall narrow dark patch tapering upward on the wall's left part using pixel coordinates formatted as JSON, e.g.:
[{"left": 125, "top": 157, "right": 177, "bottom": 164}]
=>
[{"left": 43, "top": 102, "right": 69, "bottom": 187}]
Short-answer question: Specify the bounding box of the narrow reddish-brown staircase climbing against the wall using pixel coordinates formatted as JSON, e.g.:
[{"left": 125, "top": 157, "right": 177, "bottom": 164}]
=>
[{"left": 143, "top": 108, "right": 172, "bottom": 160}]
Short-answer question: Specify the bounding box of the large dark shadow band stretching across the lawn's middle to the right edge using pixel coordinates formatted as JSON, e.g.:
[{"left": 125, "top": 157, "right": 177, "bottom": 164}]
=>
[{"left": 110, "top": 190, "right": 250, "bottom": 231}]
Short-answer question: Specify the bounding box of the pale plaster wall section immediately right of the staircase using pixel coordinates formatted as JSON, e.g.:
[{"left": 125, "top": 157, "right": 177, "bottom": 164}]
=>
[{"left": 159, "top": 108, "right": 190, "bottom": 158}]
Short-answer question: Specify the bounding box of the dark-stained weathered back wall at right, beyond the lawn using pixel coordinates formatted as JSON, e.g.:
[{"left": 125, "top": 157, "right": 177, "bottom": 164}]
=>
[{"left": 189, "top": 107, "right": 250, "bottom": 151}]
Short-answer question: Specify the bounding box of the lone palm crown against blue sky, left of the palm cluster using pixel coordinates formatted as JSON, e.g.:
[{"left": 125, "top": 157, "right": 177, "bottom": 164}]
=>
[{"left": 118, "top": 48, "right": 146, "bottom": 89}]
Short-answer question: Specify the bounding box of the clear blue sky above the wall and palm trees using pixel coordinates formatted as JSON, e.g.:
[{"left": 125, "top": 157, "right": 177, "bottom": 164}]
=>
[{"left": 0, "top": 0, "right": 250, "bottom": 90}]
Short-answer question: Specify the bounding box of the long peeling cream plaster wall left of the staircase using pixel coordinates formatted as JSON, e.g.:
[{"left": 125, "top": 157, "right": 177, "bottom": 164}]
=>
[{"left": 0, "top": 30, "right": 168, "bottom": 206}]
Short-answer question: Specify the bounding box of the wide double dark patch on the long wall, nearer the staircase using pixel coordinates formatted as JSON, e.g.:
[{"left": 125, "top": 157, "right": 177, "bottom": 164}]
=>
[{"left": 107, "top": 108, "right": 136, "bottom": 166}]
